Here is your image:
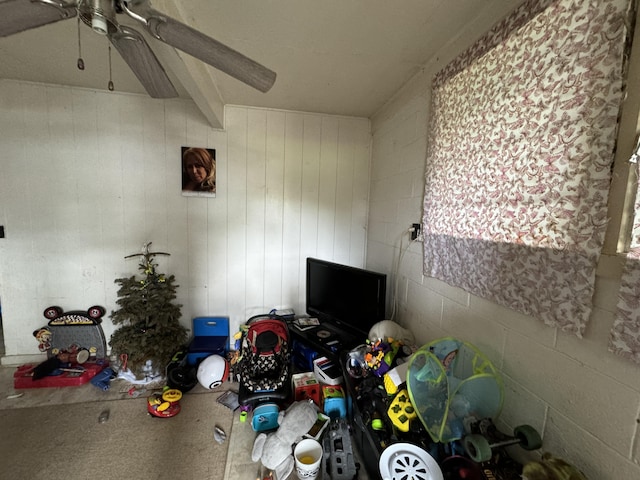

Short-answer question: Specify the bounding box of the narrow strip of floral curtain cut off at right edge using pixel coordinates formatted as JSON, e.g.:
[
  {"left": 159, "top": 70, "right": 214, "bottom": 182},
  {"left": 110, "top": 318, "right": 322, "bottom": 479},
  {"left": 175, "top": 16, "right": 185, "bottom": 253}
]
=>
[{"left": 609, "top": 156, "right": 640, "bottom": 363}]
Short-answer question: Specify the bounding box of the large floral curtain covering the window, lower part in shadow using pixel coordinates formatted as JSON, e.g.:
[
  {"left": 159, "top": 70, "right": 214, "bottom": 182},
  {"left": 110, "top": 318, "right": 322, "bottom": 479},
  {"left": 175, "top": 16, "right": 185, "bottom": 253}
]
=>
[{"left": 423, "top": 0, "right": 630, "bottom": 337}]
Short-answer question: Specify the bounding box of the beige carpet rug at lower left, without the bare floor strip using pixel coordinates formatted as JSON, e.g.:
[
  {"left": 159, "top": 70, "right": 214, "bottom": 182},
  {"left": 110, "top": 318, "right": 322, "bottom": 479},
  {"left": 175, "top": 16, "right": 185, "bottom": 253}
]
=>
[{"left": 0, "top": 395, "right": 232, "bottom": 480}]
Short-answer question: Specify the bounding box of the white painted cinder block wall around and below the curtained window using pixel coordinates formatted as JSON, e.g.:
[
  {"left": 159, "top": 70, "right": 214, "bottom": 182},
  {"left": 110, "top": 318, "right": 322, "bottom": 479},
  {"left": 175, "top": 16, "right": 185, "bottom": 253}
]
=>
[{"left": 367, "top": 73, "right": 640, "bottom": 480}]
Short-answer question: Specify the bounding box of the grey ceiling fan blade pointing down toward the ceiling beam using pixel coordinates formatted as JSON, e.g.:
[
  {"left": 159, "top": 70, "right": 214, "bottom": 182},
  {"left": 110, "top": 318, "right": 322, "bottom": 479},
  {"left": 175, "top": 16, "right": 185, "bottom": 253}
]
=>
[{"left": 109, "top": 25, "right": 178, "bottom": 98}]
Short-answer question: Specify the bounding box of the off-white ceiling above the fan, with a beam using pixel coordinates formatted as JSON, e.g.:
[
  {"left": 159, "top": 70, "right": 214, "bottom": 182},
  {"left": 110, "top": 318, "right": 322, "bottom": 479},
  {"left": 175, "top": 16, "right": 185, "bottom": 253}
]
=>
[{"left": 0, "top": 0, "right": 522, "bottom": 126}]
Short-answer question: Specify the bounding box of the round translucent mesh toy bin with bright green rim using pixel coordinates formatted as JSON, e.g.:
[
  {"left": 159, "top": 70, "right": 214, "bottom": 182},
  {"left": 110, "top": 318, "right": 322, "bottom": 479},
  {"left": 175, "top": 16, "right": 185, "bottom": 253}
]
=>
[{"left": 407, "top": 337, "right": 504, "bottom": 443}]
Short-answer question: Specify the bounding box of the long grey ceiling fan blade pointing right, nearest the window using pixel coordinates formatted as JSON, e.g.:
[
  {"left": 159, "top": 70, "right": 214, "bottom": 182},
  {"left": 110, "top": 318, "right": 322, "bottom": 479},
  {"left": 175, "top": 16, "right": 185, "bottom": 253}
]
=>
[{"left": 127, "top": 7, "right": 276, "bottom": 92}]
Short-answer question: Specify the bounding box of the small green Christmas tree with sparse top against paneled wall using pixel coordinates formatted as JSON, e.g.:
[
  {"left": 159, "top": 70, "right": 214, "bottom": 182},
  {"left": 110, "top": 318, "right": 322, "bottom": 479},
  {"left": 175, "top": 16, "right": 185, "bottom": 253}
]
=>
[{"left": 109, "top": 242, "right": 187, "bottom": 378}]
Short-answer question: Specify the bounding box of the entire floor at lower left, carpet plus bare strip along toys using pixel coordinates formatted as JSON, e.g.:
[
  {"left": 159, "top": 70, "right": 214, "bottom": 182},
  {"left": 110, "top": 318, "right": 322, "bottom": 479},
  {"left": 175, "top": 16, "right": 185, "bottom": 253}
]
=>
[{"left": 0, "top": 367, "right": 264, "bottom": 480}]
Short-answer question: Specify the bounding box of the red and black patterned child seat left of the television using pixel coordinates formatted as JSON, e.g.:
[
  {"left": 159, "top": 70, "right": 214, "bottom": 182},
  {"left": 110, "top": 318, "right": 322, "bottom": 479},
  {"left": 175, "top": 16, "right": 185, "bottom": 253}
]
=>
[{"left": 238, "top": 315, "right": 291, "bottom": 393}]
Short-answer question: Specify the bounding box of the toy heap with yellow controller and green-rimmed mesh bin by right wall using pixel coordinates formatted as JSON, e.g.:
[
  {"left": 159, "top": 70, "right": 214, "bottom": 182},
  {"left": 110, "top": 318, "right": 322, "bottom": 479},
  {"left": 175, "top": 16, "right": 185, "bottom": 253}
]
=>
[{"left": 345, "top": 335, "right": 542, "bottom": 480}]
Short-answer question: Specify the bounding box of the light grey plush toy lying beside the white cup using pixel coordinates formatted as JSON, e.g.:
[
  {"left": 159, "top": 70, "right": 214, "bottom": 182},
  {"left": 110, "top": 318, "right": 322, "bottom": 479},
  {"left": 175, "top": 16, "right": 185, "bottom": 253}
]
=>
[{"left": 251, "top": 400, "right": 318, "bottom": 480}]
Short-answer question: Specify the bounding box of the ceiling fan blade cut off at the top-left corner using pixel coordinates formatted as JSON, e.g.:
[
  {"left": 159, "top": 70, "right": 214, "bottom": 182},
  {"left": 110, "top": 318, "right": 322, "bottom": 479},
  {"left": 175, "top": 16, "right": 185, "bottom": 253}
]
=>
[{"left": 0, "top": 0, "right": 78, "bottom": 37}]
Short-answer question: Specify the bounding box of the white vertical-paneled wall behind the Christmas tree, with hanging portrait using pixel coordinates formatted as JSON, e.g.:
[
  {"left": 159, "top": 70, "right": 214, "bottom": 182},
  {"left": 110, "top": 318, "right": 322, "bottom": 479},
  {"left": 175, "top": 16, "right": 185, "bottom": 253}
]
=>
[{"left": 0, "top": 80, "right": 370, "bottom": 363}]
